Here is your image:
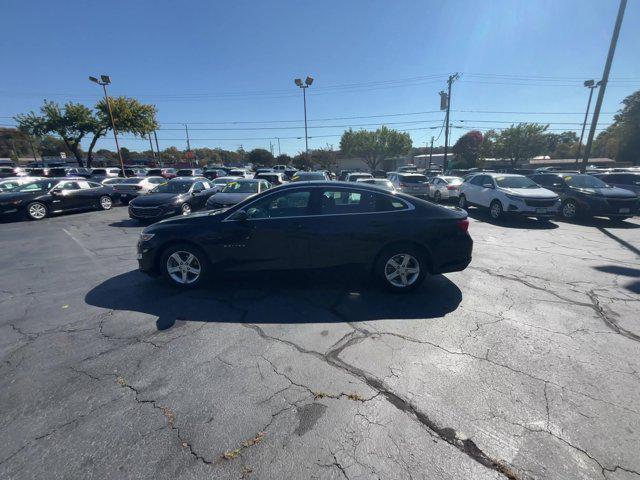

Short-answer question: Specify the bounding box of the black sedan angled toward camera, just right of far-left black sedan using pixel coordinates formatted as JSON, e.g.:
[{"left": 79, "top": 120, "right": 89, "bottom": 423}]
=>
[{"left": 129, "top": 177, "right": 216, "bottom": 221}]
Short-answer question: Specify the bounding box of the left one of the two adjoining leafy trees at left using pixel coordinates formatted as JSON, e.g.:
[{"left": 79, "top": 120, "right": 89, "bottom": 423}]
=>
[{"left": 15, "top": 100, "right": 97, "bottom": 166}]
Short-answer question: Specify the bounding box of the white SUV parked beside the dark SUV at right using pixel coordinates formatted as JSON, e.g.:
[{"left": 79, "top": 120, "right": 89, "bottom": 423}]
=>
[{"left": 458, "top": 172, "right": 561, "bottom": 220}]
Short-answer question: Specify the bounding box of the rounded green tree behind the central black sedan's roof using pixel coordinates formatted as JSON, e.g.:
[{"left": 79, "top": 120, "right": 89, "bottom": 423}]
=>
[{"left": 340, "top": 125, "right": 412, "bottom": 171}]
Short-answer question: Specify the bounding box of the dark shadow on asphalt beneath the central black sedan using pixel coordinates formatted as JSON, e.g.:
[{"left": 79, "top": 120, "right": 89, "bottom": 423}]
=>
[{"left": 85, "top": 270, "right": 462, "bottom": 330}]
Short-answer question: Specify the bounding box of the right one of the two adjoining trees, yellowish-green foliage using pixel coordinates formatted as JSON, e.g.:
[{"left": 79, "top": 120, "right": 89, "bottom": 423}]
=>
[{"left": 87, "top": 97, "right": 158, "bottom": 167}]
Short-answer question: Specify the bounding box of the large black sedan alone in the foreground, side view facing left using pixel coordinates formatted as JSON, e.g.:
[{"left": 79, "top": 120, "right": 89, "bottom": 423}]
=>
[{"left": 138, "top": 181, "right": 473, "bottom": 292}]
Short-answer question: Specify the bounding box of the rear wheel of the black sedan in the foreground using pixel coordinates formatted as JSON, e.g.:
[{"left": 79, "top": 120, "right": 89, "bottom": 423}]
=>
[{"left": 374, "top": 244, "right": 429, "bottom": 293}]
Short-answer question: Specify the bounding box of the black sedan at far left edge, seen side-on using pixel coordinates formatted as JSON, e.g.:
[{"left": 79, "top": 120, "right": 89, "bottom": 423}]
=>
[{"left": 0, "top": 178, "right": 115, "bottom": 220}]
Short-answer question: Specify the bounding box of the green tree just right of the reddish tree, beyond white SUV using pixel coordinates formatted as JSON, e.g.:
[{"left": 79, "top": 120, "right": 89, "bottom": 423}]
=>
[{"left": 496, "top": 123, "right": 549, "bottom": 168}]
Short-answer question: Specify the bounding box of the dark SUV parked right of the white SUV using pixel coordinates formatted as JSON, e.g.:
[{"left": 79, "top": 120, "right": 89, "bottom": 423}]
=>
[{"left": 530, "top": 172, "right": 638, "bottom": 220}]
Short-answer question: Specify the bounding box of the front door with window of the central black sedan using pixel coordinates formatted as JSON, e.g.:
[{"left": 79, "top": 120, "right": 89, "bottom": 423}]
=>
[{"left": 215, "top": 188, "right": 314, "bottom": 271}]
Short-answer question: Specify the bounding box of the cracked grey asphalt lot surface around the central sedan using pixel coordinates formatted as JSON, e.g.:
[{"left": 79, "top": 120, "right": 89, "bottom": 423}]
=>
[{"left": 0, "top": 208, "right": 640, "bottom": 480}]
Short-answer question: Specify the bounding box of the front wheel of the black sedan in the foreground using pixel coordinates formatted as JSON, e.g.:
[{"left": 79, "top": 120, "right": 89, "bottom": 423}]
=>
[{"left": 160, "top": 243, "right": 209, "bottom": 289}]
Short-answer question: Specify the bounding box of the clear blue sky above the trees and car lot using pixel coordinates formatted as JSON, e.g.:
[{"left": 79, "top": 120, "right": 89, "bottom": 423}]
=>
[{"left": 0, "top": 0, "right": 640, "bottom": 154}]
